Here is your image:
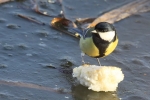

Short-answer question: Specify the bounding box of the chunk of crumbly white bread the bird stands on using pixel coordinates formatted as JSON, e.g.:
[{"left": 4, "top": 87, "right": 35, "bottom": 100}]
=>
[{"left": 73, "top": 65, "right": 124, "bottom": 92}]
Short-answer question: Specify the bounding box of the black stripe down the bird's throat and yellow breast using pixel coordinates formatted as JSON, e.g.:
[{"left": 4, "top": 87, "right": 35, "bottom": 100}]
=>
[{"left": 92, "top": 33, "right": 116, "bottom": 58}]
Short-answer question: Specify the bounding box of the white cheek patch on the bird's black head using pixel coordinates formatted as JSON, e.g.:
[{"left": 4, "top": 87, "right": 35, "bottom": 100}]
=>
[{"left": 98, "top": 31, "right": 115, "bottom": 42}]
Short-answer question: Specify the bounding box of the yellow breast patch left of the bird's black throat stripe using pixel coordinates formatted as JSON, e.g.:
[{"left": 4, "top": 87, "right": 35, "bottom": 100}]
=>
[{"left": 79, "top": 37, "right": 99, "bottom": 57}]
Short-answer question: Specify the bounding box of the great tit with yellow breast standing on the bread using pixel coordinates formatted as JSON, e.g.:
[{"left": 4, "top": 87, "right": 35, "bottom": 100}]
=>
[{"left": 71, "top": 22, "right": 118, "bottom": 66}]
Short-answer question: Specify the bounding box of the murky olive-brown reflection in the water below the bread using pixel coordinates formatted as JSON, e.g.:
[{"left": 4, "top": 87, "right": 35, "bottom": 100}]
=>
[{"left": 72, "top": 85, "right": 120, "bottom": 100}]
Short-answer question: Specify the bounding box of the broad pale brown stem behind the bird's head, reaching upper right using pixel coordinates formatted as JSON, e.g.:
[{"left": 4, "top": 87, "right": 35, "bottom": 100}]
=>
[{"left": 88, "top": 0, "right": 150, "bottom": 27}]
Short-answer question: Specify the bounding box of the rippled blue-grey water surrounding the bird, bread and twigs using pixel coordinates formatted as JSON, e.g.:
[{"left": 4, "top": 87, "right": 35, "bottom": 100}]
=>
[{"left": 0, "top": 0, "right": 150, "bottom": 100}]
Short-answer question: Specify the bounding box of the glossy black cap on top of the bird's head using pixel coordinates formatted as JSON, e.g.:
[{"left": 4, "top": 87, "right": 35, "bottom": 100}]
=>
[{"left": 95, "top": 22, "right": 115, "bottom": 32}]
